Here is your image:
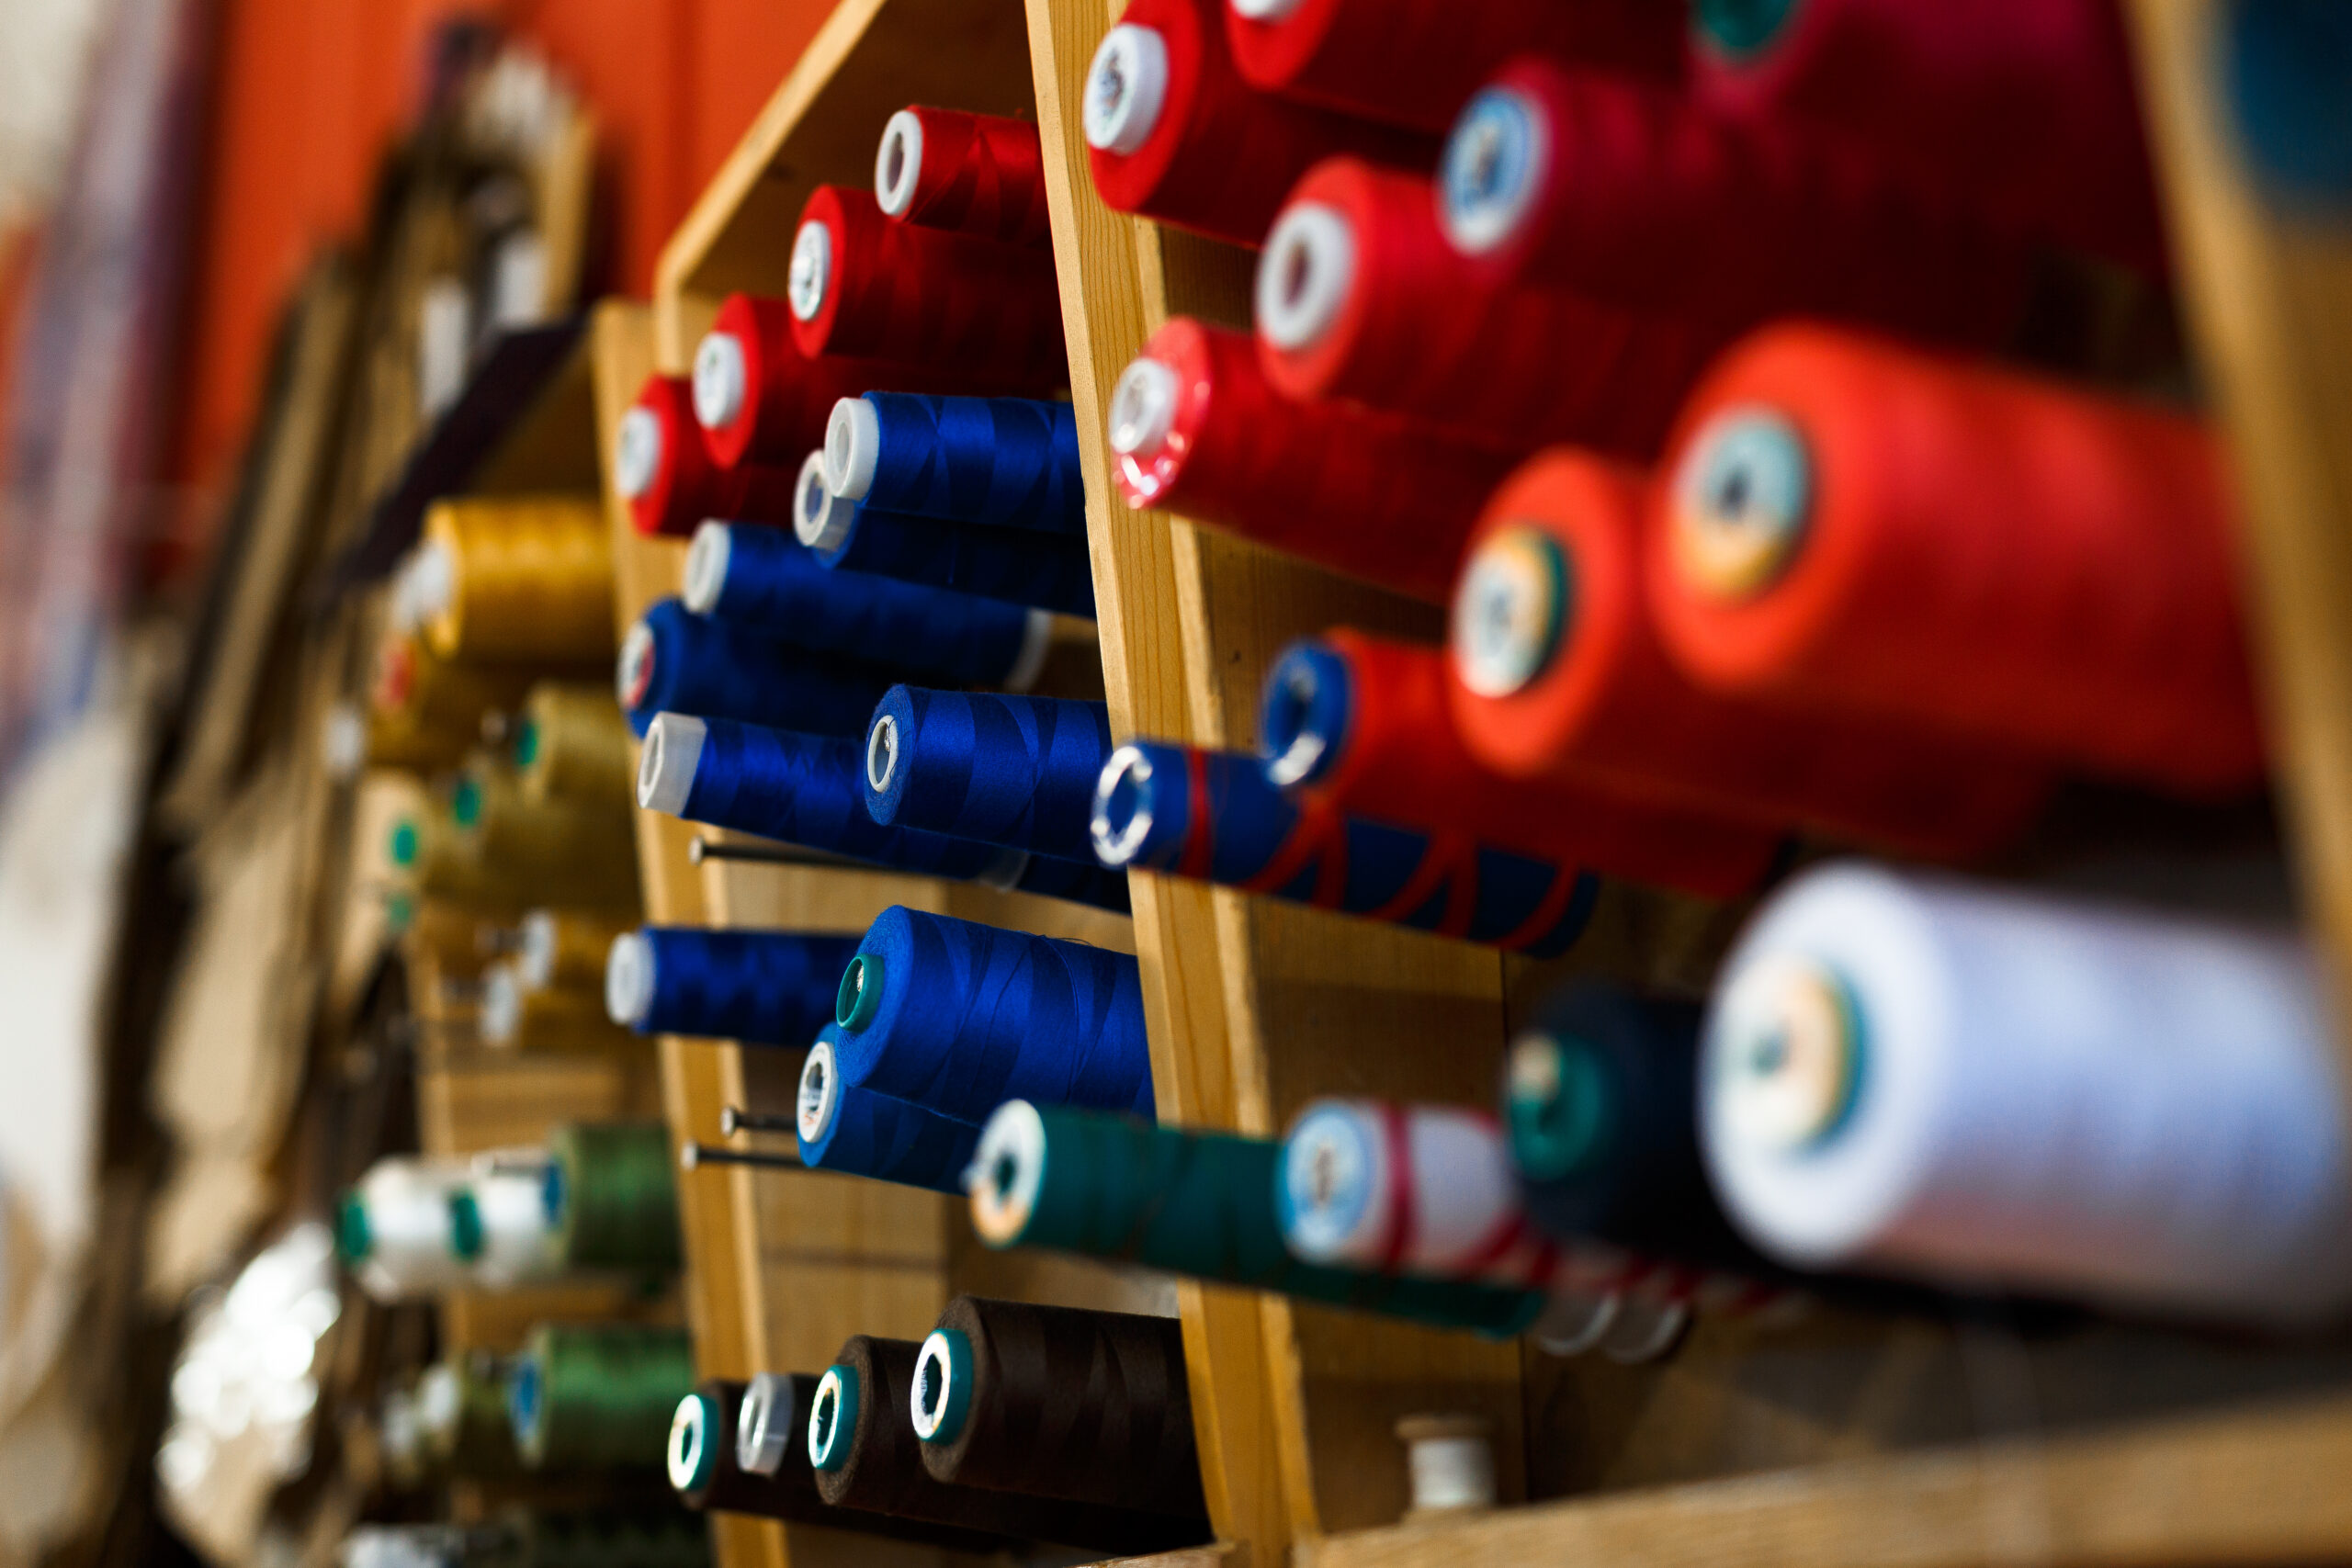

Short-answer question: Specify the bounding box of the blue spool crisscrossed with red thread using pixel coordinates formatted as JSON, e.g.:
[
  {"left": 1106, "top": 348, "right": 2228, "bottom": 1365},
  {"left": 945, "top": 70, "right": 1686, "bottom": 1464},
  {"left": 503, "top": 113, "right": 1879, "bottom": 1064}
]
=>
[{"left": 1093, "top": 740, "right": 1600, "bottom": 957}]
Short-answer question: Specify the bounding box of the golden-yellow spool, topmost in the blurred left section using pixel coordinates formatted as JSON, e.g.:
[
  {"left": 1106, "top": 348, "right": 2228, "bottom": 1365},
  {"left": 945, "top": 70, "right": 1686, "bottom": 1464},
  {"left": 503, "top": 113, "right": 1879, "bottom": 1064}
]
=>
[{"left": 424, "top": 496, "right": 614, "bottom": 663}]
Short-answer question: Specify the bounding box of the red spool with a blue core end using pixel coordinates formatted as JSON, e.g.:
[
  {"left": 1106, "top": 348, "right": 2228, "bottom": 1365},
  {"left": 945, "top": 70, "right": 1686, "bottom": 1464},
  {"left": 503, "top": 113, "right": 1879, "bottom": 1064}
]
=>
[{"left": 1259, "top": 630, "right": 1781, "bottom": 898}]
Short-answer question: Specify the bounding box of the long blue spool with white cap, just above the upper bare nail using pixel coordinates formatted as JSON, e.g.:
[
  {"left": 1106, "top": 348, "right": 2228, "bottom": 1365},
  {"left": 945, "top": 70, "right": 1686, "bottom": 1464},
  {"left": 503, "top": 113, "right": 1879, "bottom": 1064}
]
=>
[{"left": 638, "top": 712, "right": 1126, "bottom": 909}]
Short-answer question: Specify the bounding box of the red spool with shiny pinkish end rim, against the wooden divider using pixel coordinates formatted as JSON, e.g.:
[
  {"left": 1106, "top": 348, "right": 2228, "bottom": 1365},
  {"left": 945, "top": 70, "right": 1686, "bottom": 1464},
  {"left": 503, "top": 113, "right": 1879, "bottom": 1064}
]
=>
[{"left": 1110, "top": 317, "right": 1510, "bottom": 604}]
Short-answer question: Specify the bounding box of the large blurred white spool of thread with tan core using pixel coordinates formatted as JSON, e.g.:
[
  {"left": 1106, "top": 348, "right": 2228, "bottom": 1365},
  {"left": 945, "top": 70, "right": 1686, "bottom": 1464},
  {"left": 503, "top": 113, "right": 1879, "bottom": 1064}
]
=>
[{"left": 1701, "top": 865, "right": 2352, "bottom": 1324}]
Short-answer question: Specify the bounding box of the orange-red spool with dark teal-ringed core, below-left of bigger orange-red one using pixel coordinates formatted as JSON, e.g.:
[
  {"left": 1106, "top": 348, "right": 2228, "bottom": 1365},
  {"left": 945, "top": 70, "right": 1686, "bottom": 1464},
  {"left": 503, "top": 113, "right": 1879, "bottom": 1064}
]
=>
[{"left": 1449, "top": 451, "right": 2046, "bottom": 861}]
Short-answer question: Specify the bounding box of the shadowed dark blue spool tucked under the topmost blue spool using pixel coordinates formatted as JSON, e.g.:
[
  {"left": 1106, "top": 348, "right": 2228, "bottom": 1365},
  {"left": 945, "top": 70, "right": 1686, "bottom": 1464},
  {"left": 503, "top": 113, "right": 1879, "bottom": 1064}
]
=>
[{"left": 793, "top": 451, "right": 1093, "bottom": 621}]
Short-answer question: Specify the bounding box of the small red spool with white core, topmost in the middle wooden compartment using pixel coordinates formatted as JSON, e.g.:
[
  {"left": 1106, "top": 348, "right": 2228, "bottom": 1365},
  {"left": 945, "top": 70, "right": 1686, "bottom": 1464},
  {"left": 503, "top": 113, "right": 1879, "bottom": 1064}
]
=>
[{"left": 875, "top": 106, "right": 1054, "bottom": 249}]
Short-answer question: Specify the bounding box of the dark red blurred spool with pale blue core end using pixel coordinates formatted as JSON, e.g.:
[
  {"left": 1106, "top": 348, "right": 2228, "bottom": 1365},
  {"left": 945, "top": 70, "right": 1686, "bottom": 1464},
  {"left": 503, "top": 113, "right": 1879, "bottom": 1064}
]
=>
[{"left": 1440, "top": 59, "right": 2034, "bottom": 348}]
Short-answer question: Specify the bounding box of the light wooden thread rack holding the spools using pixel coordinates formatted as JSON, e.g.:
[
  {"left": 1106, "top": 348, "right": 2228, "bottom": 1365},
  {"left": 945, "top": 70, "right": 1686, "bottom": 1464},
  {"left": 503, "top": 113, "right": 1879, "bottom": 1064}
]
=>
[{"left": 611, "top": 0, "right": 2352, "bottom": 1568}]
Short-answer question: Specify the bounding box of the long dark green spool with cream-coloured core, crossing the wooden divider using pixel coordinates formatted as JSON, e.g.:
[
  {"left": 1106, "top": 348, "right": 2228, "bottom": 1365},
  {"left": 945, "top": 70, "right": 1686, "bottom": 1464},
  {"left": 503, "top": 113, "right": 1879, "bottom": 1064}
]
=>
[{"left": 971, "top": 1100, "right": 1543, "bottom": 1337}]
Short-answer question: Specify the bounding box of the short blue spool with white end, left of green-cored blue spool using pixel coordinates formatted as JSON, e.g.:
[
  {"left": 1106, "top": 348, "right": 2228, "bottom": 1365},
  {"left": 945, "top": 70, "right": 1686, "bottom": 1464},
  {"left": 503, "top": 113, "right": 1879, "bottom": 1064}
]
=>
[{"left": 605, "top": 926, "right": 858, "bottom": 1046}]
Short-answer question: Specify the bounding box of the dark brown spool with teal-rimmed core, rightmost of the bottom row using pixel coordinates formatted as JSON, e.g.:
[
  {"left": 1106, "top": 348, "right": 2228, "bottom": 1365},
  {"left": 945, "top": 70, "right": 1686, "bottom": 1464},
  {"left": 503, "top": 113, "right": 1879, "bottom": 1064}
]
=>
[{"left": 908, "top": 1295, "right": 1211, "bottom": 1542}]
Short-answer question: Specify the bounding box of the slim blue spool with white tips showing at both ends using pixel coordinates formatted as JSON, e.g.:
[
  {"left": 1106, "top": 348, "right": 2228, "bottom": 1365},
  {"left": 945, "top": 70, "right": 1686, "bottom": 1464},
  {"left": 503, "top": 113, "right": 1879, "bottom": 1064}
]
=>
[{"left": 684, "top": 522, "right": 1054, "bottom": 691}]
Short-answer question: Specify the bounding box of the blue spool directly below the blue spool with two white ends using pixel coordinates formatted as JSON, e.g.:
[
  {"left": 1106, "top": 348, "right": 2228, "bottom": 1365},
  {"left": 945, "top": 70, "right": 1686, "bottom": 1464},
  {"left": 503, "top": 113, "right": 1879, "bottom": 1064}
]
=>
[{"left": 618, "top": 600, "right": 896, "bottom": 739}]
